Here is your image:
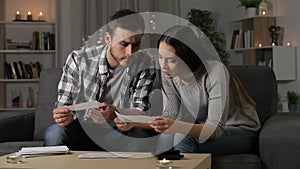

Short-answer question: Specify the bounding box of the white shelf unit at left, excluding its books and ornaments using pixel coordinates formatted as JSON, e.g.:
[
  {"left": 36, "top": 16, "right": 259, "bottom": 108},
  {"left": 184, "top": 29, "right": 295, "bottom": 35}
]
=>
[{"left": 0, "top": 21, "right": 57, "bottom": 111}]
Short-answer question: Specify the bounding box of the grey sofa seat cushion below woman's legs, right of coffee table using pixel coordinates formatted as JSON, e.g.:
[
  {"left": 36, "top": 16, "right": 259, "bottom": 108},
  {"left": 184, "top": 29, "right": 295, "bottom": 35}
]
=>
[{"left": 212, "top": 154, "right": 261, "bottom": 169}]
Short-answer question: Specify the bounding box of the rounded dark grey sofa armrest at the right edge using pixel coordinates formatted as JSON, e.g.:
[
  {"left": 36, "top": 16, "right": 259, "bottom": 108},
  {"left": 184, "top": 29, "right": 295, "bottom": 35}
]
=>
[{"left": 259, "top": 113, "right": 300, "bottom": 169}]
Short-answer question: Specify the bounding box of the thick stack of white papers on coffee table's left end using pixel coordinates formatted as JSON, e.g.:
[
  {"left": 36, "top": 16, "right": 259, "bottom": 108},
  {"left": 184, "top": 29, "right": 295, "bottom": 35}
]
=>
[{"left": 16, "top": 146, "right": 69, "bottom": 157}]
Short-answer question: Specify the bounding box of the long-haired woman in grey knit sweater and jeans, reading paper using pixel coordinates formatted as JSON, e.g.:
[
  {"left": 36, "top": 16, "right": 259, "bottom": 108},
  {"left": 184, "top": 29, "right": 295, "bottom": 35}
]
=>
[{"left": 148, "top": 26, "right": 260, "bottom": 155}]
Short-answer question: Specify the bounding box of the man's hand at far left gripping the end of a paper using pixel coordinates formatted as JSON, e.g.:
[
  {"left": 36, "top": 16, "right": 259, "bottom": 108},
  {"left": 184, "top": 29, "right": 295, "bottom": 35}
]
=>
[{"left": 52, "top": 108, "right": 73, "bottom": 126}]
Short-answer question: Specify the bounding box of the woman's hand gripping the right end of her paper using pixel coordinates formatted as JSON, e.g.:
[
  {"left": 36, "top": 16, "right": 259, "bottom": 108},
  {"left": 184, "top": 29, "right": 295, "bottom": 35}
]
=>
[{"left": 148, "top": 116, "right": 176, "bottom": 134}]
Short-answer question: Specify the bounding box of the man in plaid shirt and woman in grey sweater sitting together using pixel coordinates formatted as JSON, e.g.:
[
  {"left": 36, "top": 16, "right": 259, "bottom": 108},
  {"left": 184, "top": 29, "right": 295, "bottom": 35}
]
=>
[{"left": 44, "top": 10, "right": 260, "bottom": 154}]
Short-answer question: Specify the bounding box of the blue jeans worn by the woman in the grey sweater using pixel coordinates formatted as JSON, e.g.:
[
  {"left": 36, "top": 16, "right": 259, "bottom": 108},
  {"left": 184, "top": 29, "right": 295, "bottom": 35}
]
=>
[{"left": 174, "top": 126, "right": 258, "bottom": 155}]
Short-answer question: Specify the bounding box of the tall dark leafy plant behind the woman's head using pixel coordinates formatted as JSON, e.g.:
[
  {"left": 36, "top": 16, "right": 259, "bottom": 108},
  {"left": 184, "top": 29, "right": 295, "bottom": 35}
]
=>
[{"left": 187, "top": 9, "right": 229, "bottom": 64}]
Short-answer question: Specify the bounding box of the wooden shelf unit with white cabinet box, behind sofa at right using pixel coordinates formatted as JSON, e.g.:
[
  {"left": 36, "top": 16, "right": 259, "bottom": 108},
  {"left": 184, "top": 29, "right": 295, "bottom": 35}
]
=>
[{"left": 228, "top": 16, "right": 296, "bottom": 81}]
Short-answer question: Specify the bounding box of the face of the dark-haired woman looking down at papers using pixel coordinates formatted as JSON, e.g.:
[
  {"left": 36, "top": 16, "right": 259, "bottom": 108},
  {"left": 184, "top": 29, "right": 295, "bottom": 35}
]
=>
[{"left": 158, "top": 42, "right": 191, "bottom": 79}]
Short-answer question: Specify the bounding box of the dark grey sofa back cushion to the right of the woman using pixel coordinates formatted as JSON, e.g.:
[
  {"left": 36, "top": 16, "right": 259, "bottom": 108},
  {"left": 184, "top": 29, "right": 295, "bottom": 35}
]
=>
[{"left": 231, "top": 66, "right": 277, "bottom": 124}]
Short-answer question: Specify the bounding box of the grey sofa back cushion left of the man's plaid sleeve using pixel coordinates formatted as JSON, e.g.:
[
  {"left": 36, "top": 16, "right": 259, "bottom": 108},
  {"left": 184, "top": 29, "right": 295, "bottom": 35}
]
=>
[{"left": 34, "top": 68, "right": 62, "bottom": 140}]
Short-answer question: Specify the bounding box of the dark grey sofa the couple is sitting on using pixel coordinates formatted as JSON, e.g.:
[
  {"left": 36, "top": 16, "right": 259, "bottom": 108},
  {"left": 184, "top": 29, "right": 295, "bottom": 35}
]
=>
[{"left": 0, "top": 66, "right": 300, "bottom": 169}]
